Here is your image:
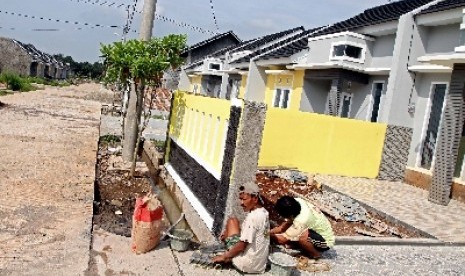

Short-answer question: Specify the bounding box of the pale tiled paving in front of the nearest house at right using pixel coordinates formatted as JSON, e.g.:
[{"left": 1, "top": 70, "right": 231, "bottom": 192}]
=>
[{"left": 315, "top": 175, "right": 465, "bottom": 243}]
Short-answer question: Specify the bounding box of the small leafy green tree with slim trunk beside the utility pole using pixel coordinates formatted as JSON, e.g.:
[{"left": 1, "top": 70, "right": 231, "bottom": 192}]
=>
[{"left": 100, "top": 34, "right": 186, "bottom": 174}]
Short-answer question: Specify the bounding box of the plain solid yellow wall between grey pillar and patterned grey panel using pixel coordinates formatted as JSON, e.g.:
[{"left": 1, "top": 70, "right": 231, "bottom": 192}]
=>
[{"left": 259, "top": 108, "right": 387, "bottom": 178}]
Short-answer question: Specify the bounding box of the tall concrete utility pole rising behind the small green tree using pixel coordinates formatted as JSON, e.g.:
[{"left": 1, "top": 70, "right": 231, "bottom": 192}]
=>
[{"left": 122, "top": 0, "right": 157, "bottom": 166}]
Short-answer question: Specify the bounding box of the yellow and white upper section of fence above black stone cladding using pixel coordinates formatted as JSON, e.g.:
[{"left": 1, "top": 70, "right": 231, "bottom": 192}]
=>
[{"left": 169, "top": 91, "right": 231, "bottom": 172}]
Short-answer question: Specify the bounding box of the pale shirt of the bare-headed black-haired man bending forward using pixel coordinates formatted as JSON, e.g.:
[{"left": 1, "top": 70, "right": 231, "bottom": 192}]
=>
[{"left": 284, "top": 198, "right": 335, "bottom": 247}]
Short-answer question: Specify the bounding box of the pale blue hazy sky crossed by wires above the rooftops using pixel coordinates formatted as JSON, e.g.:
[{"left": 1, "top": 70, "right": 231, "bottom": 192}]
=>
[{"left": 0, "top": 0, "right": 389, "bottom": 62}]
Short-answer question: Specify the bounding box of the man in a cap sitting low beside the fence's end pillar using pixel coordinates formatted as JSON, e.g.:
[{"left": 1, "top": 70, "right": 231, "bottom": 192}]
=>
[{"left": 213, "top": 182, "right": 270, "bottom": 273}]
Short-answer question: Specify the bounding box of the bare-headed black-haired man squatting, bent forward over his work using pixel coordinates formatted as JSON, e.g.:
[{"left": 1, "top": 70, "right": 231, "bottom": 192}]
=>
[{"left": 270, "top": 196, "right": 335, "bottom": 259}]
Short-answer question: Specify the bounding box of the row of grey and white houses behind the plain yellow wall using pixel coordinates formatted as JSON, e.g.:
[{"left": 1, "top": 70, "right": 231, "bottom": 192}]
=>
[{"left": 171, "top": 0, "right": 465, "bottom": 207}]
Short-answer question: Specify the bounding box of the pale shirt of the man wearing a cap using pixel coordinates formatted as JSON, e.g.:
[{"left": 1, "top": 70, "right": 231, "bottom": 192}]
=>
[{"left": 232, "top": 207, "right": 270, "bottom": 273}]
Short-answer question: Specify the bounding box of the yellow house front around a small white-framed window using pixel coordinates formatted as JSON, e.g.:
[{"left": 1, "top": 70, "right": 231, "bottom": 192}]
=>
[{"left": 265, "top": 70, "right": 305, "bottom": 111}]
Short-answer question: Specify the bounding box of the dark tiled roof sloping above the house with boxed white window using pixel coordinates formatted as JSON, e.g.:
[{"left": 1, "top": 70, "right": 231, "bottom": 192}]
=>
[{"left": 260, "top": 0, "right": 432, "bottom": 59}]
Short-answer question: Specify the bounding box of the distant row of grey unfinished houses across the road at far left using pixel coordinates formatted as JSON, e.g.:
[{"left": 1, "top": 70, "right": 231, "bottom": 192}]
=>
[{"left": 0, "top": 37, "right": 71, "bottom": 79}]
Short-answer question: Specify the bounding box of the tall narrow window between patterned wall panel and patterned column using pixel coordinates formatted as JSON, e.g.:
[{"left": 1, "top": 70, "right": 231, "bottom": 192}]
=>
[{"left": 420, "top": 83, "right": 447, "bottom": 170}]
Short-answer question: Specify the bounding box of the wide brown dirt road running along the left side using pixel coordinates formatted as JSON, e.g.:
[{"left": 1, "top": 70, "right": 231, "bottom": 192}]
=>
[{"left": 0, "top": 84, "right": 112, "bottom": 275}]
